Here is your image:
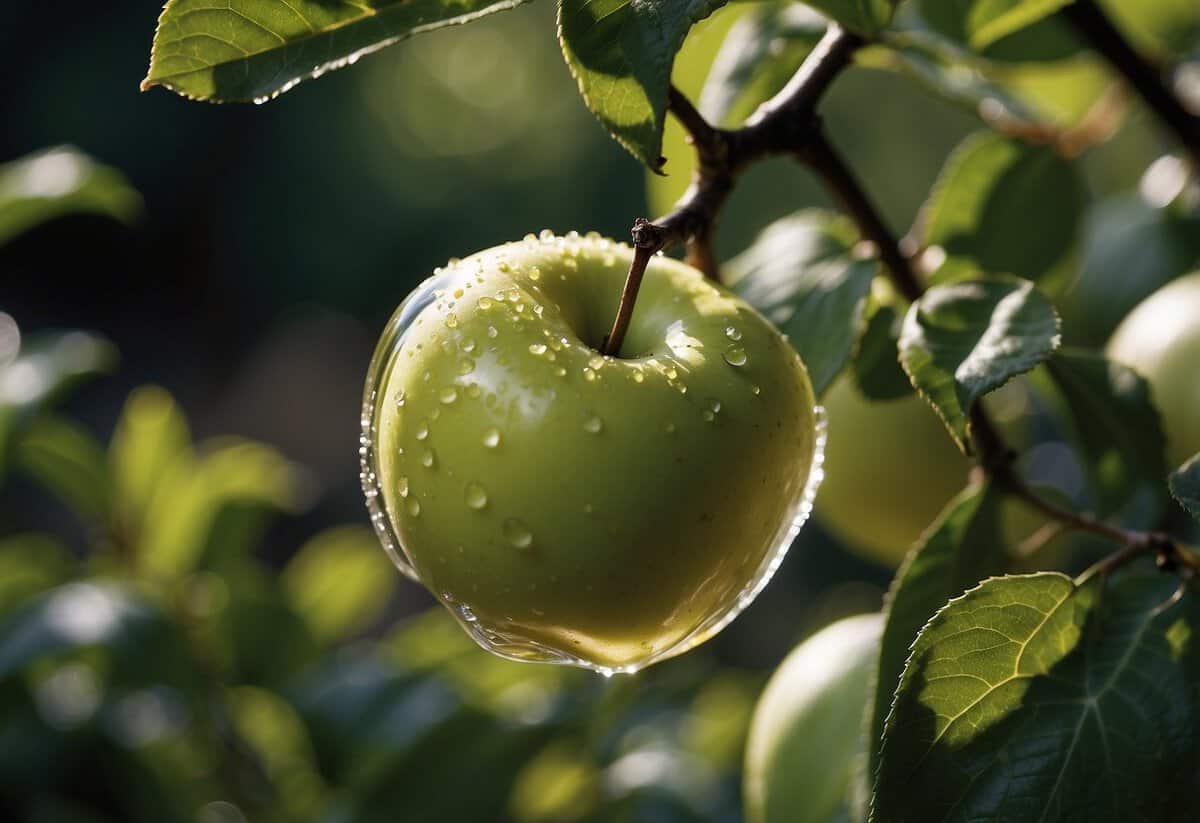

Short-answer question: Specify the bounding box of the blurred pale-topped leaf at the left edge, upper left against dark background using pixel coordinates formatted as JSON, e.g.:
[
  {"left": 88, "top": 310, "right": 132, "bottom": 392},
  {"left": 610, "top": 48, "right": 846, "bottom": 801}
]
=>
[{"left": 0, "top": 145, "right": 142, "bottom": 246}]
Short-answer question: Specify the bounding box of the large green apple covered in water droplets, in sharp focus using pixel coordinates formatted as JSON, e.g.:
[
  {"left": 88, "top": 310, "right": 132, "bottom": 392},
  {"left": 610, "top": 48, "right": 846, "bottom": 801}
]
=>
[{"left": 362, "top": 233, "right": 821, "bottom": 673}]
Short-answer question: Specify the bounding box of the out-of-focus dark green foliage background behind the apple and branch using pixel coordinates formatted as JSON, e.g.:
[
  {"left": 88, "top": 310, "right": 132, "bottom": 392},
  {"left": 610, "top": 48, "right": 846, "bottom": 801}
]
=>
[{"left": 0, "top": 0, "right": 1200, "bottom": 823}]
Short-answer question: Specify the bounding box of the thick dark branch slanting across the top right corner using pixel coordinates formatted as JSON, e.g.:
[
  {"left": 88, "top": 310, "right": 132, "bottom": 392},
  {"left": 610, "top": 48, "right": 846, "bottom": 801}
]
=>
[{"left": 1061, "top": 0, "right": 1200, "bottom": 167}]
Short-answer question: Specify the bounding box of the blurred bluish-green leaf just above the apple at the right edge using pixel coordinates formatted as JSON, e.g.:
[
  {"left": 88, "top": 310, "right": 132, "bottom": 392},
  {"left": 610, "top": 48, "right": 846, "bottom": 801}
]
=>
[{"left": 1063, "top": 194, "right": 1200, "bottom": 344}]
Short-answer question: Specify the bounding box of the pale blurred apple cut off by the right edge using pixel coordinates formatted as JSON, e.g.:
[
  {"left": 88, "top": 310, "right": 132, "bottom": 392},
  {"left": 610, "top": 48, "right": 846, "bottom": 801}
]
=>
[{"left": 1106, "top": 271, "right": 1200, "bottom": 467}]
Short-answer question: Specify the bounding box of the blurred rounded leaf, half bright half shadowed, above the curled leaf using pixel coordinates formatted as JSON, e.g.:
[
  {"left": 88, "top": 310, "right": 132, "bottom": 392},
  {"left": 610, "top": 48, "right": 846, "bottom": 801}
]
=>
[{"left": 922, "top": 133, "right": 1087, "bottom": 286}]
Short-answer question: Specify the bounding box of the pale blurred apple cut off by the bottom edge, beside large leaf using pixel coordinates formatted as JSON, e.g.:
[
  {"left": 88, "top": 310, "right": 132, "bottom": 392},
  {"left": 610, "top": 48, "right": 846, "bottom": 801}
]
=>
[{"left": 744, "top": 614, "right": 883, "bottom": 823}]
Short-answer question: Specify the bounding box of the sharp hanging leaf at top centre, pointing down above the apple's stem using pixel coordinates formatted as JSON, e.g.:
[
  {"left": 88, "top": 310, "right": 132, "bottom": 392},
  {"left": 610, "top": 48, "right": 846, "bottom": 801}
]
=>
[{"left": 558, "top": 0, "right": 725, "bottom": 169}]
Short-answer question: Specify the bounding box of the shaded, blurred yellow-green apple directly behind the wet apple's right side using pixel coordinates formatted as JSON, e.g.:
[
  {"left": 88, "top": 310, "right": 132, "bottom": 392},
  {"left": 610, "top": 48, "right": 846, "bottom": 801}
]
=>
[{"left": 816, "top": 378, "right": 971, "bottom": 566}]
